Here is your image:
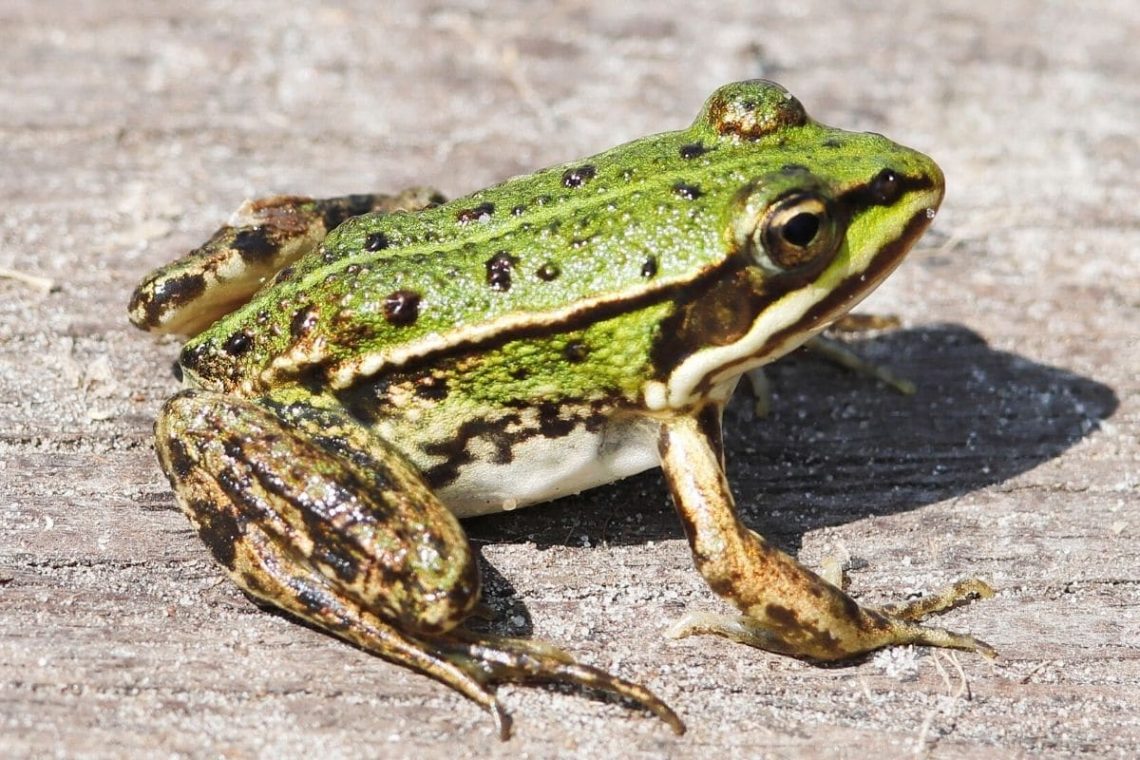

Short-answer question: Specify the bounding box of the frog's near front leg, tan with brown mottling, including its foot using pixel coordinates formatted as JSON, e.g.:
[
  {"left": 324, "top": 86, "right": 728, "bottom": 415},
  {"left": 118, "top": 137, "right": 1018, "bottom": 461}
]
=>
[{"left": 659, "top": 404, "right": 995, "bottom": 660}]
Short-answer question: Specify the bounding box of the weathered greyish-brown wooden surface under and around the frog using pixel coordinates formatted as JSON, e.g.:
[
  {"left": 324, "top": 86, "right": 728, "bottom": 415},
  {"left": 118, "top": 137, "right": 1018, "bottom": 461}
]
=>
[{"left": 0, "top": 0, "right": 1140, "bottom": 758}]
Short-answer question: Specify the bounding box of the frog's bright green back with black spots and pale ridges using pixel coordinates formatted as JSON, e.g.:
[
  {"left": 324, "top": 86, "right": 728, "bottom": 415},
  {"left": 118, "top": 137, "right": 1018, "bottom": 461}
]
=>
[{"left": 173, "top": 82, "right": 829, "bottom": 393}]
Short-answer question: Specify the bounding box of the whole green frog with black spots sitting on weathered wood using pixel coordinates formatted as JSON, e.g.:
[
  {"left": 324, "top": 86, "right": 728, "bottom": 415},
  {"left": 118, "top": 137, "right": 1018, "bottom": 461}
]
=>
[{"left": 129, "top": 80, "right": 994, "bottom": 738}]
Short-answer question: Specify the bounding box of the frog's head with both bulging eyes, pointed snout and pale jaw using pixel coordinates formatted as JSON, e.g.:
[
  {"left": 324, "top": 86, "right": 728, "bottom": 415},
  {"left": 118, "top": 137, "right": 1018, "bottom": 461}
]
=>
[{"left": 662, "top": 81, "right": 944, "bottom": 408}]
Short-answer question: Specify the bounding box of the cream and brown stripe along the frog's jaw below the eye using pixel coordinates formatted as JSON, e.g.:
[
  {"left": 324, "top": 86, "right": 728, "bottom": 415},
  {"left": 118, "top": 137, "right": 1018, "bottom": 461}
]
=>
[{"left": 661, "top": 193, "right": 938, "bottom": 411}]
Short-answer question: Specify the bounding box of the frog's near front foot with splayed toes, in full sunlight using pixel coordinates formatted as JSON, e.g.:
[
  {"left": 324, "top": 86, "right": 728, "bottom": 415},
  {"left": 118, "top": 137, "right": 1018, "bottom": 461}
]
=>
[{"left": 668, "top": 576, "right": 998, "bottom": 661}]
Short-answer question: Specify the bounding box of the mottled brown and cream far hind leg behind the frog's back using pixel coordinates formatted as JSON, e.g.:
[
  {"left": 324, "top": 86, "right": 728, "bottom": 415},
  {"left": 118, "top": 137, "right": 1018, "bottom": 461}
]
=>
[{"left": 129, "top": 187, "right": 443, "bottom": 335}]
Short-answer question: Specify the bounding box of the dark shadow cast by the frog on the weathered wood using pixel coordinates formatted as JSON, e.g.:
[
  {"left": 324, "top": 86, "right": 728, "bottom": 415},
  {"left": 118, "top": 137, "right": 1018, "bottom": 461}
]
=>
[{"left": 465, "top": 325, "right": 1118, "bottom": 635}]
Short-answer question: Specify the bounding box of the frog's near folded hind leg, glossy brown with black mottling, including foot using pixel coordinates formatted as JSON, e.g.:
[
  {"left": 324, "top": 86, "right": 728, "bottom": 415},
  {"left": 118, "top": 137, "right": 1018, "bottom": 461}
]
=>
[{"left": 155, "top": 391, "right": 684, "bottom": 737}]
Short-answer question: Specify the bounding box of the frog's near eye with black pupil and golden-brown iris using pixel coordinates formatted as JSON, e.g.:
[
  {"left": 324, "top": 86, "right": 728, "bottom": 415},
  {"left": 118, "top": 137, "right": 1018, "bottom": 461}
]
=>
[{"left": 752, "top": 193, "right": 842, "bottom": 273}]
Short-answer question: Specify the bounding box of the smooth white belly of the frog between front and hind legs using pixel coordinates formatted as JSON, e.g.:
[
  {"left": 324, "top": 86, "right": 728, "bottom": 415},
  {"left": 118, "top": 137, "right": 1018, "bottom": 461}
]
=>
[{"left": 437, "top": 419, "right": 660, "bottom": 517}]
